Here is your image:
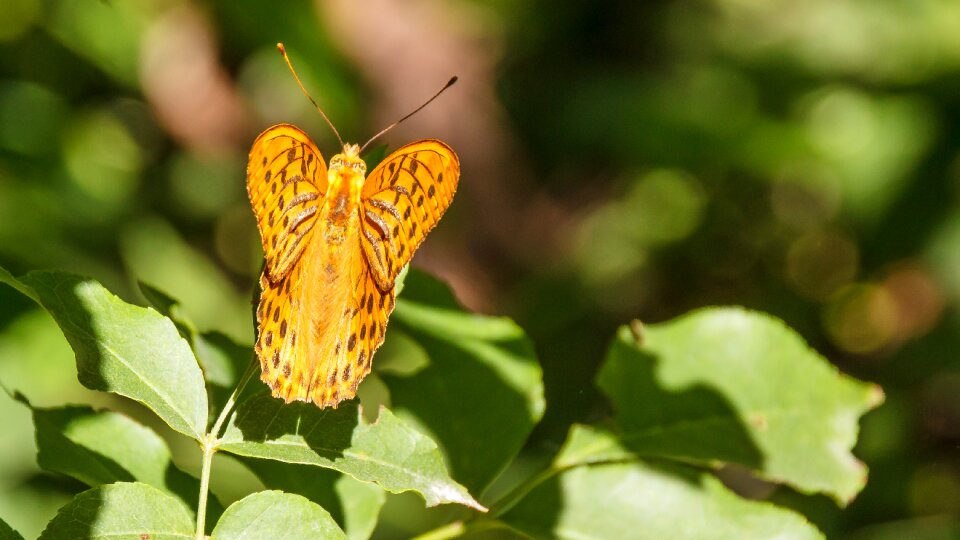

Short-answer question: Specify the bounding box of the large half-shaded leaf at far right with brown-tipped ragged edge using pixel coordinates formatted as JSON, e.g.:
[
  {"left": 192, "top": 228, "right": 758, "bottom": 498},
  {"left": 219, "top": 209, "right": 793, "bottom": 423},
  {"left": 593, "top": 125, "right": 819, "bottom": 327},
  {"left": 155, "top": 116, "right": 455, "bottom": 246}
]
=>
[{"left": 598, "top": 308, "right": 883, "bottom": 504}]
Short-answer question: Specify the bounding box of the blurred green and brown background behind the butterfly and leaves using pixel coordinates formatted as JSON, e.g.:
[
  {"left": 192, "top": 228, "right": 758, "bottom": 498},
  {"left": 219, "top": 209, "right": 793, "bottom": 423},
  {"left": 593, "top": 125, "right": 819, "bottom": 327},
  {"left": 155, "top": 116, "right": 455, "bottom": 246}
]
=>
[{"left": 0, "top": 0, "right": 960, "bottom": 538}]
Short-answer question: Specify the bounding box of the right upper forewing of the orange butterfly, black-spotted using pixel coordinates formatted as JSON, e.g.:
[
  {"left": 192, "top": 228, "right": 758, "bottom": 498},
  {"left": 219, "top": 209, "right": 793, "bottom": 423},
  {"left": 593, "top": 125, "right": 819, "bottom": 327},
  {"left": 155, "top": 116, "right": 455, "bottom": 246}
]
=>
[{"left": 360, "top": 139, "right": 460, "bottom": 291}]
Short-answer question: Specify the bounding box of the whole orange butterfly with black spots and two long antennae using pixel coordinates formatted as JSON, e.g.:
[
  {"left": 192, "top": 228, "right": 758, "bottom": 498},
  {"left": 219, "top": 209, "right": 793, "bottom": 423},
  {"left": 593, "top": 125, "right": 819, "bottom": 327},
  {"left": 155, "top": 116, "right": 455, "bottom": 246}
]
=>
[{"left": 247, "top": 44, "right": 460, "bottom": 408}]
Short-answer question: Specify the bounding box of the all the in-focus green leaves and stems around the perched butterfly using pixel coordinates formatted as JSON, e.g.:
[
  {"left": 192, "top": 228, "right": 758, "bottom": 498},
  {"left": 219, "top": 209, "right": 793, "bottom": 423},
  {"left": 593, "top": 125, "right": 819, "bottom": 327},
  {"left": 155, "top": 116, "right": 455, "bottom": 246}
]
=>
[{"left": 0, "top": 260, "right": 882, "bottom": 540}]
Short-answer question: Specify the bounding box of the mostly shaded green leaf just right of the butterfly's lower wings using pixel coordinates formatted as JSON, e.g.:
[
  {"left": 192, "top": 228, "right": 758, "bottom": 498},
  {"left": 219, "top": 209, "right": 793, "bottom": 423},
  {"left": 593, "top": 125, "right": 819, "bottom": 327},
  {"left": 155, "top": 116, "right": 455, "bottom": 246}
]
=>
[{"left": 375, "top": 270, "right": 544, "bottom": 492}]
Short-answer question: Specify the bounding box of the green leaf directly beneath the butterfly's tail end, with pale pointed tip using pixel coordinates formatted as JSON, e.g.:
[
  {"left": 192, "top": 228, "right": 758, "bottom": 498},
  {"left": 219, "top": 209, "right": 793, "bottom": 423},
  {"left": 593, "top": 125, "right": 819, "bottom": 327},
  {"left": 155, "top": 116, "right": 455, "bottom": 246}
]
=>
[{"left": 220, "top": 387, "right": 484, "bottom": 510}]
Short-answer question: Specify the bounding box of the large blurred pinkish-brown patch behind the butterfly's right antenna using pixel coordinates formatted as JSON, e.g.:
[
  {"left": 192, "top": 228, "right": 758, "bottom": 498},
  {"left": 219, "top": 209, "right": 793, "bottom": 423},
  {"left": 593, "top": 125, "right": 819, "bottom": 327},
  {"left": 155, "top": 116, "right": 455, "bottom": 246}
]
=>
[{"left": 316, "top": 0, "right": 566, "bottom": 309}]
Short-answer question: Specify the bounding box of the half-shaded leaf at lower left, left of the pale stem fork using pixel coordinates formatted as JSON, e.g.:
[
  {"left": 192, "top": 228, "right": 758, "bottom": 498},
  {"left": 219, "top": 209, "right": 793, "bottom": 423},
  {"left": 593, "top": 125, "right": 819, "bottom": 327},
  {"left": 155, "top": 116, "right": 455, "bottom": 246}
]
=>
[{"left": 23, "top": 400, "right": 223, "bottom": 519}]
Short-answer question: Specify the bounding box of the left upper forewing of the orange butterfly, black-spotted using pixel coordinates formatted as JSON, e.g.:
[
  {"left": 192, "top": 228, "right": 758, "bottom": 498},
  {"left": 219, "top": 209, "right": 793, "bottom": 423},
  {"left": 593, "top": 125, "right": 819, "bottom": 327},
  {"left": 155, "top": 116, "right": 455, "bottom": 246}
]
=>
[{"left": 247, "top": 124, "right": 327, "bottom": 283}]
